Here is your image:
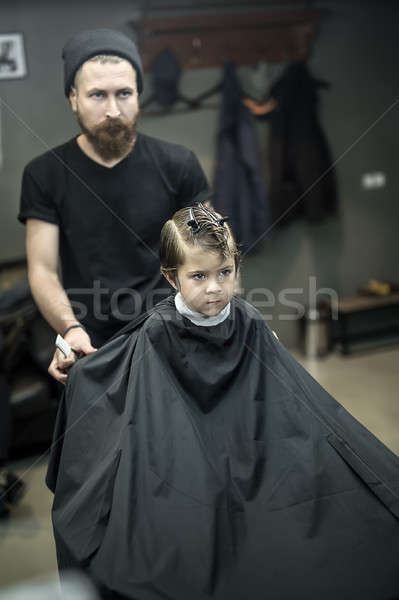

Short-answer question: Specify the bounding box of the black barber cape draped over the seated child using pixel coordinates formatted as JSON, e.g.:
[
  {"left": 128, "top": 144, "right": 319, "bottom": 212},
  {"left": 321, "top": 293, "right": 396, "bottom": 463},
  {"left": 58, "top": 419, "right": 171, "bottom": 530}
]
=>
[{"left": 47, "top": 298, "right": 399, "bottom": 600}]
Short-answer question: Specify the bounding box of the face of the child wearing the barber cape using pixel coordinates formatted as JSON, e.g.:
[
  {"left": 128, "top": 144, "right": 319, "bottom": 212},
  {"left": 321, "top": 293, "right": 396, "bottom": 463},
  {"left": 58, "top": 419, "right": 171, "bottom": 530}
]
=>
[{"left": 168, "top": 247, "right": 236, "bottom": 316}]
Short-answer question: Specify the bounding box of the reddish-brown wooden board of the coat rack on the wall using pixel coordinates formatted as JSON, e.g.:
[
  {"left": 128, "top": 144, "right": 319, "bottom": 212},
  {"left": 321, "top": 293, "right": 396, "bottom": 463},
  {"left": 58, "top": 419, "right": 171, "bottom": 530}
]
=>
[{"left": 134, "top": 10, "right": 328, "bottom": 71}]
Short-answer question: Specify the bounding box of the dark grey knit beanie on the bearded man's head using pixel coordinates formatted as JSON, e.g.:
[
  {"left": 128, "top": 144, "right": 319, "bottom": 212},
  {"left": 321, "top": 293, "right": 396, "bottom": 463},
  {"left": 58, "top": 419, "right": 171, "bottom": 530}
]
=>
[{"left": 62, "top": 29, "right": 143, "bottom": 98}]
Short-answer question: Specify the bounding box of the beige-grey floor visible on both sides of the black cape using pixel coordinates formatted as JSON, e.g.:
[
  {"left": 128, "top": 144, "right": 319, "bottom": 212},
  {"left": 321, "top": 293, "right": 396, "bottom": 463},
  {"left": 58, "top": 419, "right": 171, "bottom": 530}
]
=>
[{"left": 0, "top": 348, "right": 399, "bottom": 588}]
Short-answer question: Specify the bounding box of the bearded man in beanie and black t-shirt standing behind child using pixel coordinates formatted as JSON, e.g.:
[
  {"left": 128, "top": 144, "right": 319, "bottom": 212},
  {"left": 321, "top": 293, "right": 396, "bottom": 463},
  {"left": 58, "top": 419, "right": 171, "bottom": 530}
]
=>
[{"left": 19, "top": 29, "right": 208, "bottom": 383}]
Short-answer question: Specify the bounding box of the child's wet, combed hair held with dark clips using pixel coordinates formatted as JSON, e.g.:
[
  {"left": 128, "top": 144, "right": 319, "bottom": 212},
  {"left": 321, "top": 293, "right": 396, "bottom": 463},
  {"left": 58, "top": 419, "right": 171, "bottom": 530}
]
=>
[{"left": 159, "top": 204, "right": 240, "bottom": 272}]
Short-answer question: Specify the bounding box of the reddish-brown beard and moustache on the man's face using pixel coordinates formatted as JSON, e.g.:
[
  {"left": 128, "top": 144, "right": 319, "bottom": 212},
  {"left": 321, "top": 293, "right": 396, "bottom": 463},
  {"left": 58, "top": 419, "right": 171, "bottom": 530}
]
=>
[{"left": 77, "top": 111, "right": 138, "bottom": 162}]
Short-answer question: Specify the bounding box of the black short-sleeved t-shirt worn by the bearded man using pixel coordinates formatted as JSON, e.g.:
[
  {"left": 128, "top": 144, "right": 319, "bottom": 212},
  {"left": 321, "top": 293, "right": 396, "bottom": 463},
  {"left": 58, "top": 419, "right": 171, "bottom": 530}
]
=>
[{"left": 18, "top": 134, "right": 208, "bottom": 344}]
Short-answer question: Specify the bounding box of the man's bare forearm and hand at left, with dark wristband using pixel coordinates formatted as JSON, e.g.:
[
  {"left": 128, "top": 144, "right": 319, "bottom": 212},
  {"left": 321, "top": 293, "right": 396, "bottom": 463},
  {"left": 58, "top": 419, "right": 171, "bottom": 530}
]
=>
[{"left": 26, "top": 219, "right": 95, "bottom": 383}]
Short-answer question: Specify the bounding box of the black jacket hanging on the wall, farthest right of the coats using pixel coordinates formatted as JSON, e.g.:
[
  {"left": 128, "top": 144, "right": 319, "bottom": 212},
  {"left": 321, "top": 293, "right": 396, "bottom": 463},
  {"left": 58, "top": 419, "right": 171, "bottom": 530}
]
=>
[{"left": 267, "top": 63, "right": 337, "bottom": 224}]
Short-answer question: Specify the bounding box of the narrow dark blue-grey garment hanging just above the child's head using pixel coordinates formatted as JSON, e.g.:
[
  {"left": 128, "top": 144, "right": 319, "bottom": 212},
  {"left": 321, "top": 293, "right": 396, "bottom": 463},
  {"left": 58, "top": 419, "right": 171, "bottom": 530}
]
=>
[{"left": 214, "top": 63, "right": 269, "bottom": 250}]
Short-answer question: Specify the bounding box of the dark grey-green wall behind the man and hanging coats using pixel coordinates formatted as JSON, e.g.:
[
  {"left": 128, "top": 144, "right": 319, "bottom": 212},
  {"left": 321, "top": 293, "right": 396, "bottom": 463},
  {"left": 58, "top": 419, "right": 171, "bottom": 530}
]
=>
[{"left": 0, "top": 0, "right": 399, "bottom": 345}]
